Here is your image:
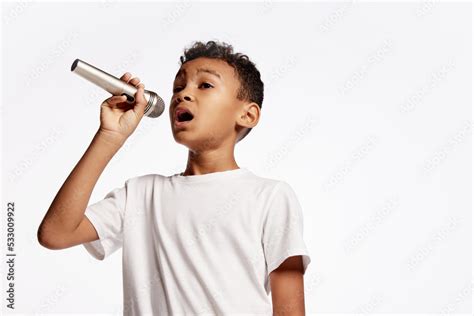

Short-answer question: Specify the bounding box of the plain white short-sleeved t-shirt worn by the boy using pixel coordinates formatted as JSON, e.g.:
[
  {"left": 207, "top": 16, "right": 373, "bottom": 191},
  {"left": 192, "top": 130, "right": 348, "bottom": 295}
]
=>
[{"left": 83, "top": 168, "right": 311, "bottom": 315}]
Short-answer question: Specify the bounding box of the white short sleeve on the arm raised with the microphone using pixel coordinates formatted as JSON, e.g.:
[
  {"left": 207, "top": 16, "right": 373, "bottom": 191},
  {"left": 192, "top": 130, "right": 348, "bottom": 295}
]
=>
[{"left": 82, "top": 183, "right": 127, "bottom": 260}]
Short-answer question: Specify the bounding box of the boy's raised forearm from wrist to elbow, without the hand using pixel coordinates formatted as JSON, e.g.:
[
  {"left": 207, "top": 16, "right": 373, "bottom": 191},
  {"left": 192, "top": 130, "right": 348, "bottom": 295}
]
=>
[{"left": 38, "top": 131, "right": 124, "bottom": 237}]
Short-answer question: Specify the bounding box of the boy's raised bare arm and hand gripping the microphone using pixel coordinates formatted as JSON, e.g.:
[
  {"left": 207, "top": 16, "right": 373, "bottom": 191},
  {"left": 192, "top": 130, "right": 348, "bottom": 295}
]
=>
[{"left": 37, "top": 72, "right": 147, "bottom": 249}]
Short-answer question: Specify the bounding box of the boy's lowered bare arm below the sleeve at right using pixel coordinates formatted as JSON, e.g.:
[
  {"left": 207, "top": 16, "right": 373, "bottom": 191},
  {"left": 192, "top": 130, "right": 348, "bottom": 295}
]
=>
[{"left": 270, "top": 256, "right": 305, "bottom": 316}]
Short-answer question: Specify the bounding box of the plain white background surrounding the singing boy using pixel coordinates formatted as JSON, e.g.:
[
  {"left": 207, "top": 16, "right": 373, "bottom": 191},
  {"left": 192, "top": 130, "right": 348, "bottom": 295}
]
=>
[{"left": 1, "top": 1, "right": 473, "bottom": 314}]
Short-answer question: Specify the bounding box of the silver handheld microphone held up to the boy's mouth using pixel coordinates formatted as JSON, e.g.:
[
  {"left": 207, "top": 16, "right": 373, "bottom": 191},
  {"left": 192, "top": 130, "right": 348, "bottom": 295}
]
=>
[{"left": 71, "top": 59, "right": 165, "bottom": 118}]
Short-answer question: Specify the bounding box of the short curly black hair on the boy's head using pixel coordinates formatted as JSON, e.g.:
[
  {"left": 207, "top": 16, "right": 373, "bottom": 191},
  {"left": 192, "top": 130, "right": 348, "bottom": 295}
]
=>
[{"left": 179, "top": 41, "right": 263, "bottom": 142}]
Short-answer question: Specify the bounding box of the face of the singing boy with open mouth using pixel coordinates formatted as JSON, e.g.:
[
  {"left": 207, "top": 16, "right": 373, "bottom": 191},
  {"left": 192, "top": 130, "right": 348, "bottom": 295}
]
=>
[{"left": 169, "top": 57, "right": 252, "bottom": 150}]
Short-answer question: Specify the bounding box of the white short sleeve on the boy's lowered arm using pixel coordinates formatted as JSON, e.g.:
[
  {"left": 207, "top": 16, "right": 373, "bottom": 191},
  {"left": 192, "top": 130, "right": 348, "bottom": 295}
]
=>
[{"left": 262, "top": 181, "right": 311, "bottom": 277}]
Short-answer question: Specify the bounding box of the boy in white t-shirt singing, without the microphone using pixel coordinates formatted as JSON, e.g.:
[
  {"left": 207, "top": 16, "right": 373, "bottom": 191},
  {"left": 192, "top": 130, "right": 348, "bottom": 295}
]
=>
[{"left": 38, "top": 41, "right": 310, "bottom": 315}]
